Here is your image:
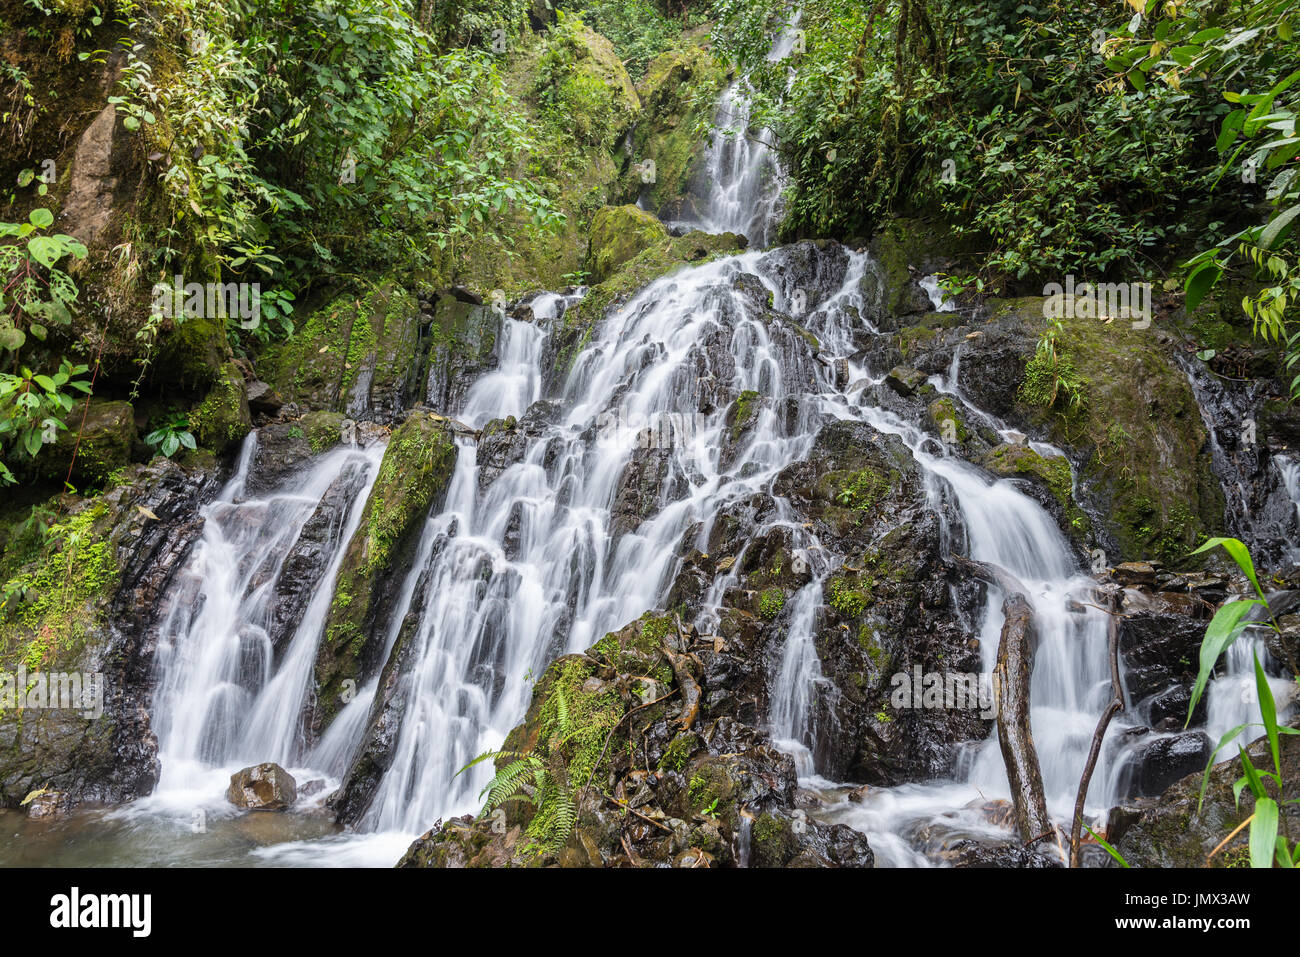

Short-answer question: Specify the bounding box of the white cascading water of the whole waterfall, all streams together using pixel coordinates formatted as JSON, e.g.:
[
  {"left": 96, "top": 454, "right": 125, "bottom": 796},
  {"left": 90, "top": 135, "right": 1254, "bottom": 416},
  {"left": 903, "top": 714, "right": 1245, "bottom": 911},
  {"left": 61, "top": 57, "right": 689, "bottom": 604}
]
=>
[{"left": 65, "top": 21, "right": 1284, "bottom": 866}]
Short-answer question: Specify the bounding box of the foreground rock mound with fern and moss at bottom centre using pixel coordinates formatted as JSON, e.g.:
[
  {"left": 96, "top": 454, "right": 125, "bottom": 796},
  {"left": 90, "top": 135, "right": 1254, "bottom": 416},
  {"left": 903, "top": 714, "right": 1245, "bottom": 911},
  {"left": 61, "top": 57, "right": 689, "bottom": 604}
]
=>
[{"left": 398, "top": 614, "right": 874, "bottom": 867}]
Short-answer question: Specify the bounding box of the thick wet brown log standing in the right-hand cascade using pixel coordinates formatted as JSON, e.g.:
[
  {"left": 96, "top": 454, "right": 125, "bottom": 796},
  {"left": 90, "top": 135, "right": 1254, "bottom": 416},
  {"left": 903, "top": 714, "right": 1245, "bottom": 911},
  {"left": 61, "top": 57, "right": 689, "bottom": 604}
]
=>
[{"left": 952, "top": 557, "right": 1056, "bottom": 844}]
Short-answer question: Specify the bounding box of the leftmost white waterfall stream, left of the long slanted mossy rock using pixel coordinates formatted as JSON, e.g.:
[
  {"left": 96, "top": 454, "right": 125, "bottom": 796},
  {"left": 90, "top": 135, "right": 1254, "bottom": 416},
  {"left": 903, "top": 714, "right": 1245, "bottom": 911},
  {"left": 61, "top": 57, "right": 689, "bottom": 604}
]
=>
[{"left": 152, "top": 433, "right": 384, "bottom": 792}]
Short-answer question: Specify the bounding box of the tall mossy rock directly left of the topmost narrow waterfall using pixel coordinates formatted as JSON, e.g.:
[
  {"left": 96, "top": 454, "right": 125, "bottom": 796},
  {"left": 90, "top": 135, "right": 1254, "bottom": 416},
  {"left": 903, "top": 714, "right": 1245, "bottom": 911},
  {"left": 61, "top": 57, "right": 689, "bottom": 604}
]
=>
[{"left": 623, "top": 46, "right": 727, "bottom": 218}]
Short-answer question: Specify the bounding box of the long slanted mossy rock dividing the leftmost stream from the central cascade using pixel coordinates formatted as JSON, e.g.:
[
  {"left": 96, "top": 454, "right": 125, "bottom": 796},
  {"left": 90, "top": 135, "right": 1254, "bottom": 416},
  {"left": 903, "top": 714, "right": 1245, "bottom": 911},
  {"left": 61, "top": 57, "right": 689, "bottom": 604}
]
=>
[{"left": 316, "top": 412, "right": 456, "bottom": 726}]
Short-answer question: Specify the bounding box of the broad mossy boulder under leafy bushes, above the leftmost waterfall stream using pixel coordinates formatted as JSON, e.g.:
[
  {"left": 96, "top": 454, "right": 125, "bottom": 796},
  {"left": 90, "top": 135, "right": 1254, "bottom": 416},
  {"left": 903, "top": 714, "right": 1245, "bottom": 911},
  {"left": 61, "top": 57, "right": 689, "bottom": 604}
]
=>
[{"left": 259, "top": 280, "right": 423, "bottom": 421}]
